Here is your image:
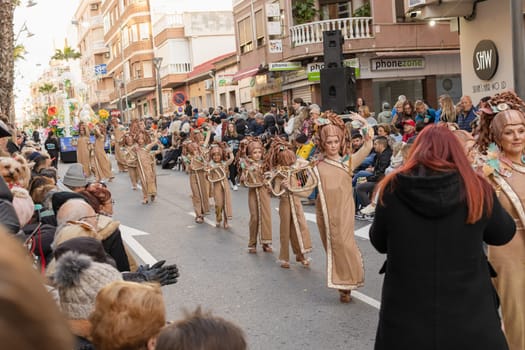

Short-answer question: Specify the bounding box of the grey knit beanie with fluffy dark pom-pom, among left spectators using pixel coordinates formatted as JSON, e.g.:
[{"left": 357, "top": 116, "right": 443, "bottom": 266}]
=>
[{"left": 54, "top": 252, "right": 122, "bottom": 320}]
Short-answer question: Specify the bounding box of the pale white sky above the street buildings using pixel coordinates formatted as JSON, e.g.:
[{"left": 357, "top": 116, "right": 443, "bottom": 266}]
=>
[{"left": 14, "top": 0, "right": 232, "bottom": 119}]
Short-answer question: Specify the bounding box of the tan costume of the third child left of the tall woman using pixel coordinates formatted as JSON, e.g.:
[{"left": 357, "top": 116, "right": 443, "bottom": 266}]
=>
[{"left": 207, "top": 156, "right": 233, "bottom": 223}]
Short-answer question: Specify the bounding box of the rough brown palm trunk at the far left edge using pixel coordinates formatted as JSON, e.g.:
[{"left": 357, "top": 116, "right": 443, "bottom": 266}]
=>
[{"left": 0, "top": 0, "right": 17, "bottom": 121}]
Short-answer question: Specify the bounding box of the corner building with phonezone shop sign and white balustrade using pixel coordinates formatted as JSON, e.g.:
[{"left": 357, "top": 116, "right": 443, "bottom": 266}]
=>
[{"left": 233, "top": 0, "right": 461, "bottom": 111}]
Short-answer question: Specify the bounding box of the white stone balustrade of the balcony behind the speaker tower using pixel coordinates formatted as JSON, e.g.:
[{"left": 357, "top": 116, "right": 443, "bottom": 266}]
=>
[{"left": 290, "top": 17, "right": 374, "bottom": 47}]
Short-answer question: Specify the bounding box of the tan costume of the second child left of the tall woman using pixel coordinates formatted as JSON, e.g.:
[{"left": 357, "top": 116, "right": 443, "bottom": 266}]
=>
[{"left": 241, "top": 160, "right": 272, "bottom": 248}]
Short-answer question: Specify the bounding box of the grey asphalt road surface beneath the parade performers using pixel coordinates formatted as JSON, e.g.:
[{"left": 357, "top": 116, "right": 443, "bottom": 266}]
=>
[{"left": 60, "top": 159, "right": 384, "bottom": 350}]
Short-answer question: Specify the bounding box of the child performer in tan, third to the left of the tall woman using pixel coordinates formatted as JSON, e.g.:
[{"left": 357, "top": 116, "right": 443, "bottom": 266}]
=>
[{"left": 207, "top": 144, "right": 234, "bottom": 229}]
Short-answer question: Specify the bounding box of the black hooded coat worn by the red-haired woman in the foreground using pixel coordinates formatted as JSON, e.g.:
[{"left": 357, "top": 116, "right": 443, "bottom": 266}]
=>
[{"left": 370, "top": 172, "right": 516, "bottom": 350}]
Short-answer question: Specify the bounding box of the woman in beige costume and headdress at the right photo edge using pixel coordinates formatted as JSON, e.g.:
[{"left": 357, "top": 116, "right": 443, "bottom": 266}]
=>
[{"left": 479, "top": 92, "right": 525, "bottom": 350}]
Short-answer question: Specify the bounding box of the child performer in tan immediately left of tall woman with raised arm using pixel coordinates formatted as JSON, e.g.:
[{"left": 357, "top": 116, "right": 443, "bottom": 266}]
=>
[{"left": 266, "top": 138, "right": 316, "bottom": 269}]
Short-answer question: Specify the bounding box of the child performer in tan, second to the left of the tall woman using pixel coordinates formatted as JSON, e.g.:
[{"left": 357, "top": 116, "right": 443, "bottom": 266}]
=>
[{"left": 238, "top": 137, "right": 273, "bottom": 254}]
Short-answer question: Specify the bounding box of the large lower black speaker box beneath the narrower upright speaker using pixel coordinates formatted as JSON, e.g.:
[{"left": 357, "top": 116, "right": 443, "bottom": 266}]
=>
[{"left": 321, "top": 67, "right": 357, "bottom": 114}]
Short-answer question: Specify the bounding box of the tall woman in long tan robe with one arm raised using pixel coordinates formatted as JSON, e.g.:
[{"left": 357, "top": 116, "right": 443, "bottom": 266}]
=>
[{"left": 314, "top": 113, "right": 374, "bottom": 303}]
